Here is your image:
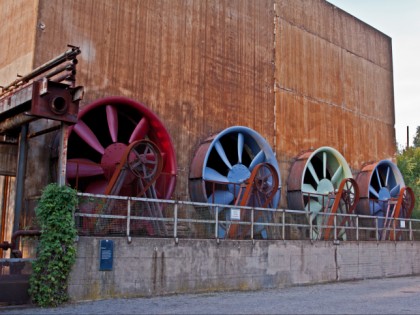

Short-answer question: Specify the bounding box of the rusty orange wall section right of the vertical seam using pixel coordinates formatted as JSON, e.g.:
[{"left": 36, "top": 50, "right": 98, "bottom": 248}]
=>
[{"left": 275, "top": 0, "right": 396, "bottom": 204}]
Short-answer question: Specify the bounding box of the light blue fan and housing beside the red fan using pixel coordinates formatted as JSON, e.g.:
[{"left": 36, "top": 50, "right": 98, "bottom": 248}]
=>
[{"left": 189, "top": 126, "right": 281, "bottom": 237}]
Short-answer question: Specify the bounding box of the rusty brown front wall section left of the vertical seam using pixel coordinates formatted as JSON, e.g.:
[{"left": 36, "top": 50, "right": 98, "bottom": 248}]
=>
[{"left": 35, "top": 0, "right": 275, "bottom": 199}]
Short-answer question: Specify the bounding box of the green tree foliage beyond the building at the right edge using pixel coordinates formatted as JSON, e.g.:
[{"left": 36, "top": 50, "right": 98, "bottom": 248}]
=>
[{"left": 397, "top": 147, "right": 420, "bottom": 219}]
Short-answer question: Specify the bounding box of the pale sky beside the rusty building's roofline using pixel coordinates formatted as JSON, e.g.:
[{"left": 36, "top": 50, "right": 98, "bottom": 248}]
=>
[{"left": 327, "top": 0, "right": 420, "bottom": 148}]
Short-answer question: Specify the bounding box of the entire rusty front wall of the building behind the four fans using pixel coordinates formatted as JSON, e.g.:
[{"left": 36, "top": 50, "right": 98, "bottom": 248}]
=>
[{"left": 0, "top": 0, "right": 395, "bottom": 212}]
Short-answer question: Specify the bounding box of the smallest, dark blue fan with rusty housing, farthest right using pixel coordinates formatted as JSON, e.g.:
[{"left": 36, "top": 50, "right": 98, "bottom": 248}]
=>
[{"left": 356, "top": 160, "right": 405, "bottom": 217}]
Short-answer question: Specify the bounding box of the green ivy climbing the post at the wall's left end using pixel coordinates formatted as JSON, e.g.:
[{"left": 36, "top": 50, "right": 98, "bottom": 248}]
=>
[{"left": 29, "top": 184, "right": 77, "bottom": 307}]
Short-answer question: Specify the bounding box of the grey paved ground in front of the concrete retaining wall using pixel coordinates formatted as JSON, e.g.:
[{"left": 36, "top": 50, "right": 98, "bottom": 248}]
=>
[{"left": 0, "top": 277, "right": 420, "bottom": 314}]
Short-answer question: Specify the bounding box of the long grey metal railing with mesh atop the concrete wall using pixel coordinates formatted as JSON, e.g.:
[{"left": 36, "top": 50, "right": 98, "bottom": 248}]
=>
[{"left": 74, "top": 193, "right": 420, "bottom": 242}]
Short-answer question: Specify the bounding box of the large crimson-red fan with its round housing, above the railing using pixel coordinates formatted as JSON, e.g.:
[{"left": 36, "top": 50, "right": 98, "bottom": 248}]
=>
[{"left": 66, "top": 97, "right": 176, "bottom": 199}]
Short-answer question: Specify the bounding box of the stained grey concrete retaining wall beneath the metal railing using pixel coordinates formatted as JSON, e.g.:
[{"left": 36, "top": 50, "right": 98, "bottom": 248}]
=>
[{"left": 69, "top": 237, "right": 420, "bottom": 300}]
